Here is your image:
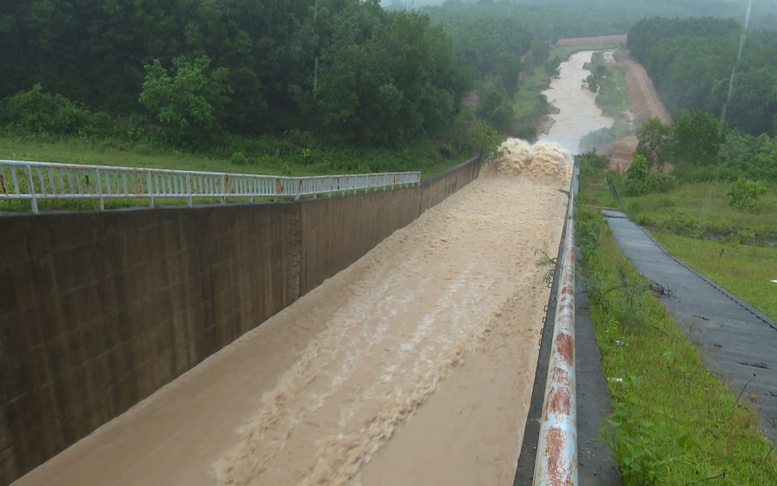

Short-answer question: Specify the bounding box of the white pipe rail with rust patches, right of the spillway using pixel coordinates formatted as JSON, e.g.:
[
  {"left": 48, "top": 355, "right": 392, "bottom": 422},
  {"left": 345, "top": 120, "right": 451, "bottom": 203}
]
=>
[{"left": 533, "top": 170, "right": 578, "bottom": 486}]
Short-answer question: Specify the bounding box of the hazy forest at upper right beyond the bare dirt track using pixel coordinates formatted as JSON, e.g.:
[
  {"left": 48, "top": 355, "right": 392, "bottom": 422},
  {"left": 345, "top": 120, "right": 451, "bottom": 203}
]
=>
[{"left": 627, "top": 18, "right": 777, "bottom": 136}]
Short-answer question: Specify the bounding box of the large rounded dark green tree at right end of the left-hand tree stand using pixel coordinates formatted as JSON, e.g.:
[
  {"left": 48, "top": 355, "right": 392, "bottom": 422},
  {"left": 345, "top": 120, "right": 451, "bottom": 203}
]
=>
[{"left": 307, "top": 12, "right": 463, "bottom": 145}]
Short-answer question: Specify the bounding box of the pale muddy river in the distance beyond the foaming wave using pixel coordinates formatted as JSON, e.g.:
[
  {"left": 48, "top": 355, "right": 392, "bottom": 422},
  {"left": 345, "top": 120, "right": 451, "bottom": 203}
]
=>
[{"left": 540, "top": 51, "right": 613, "bottom": 154}]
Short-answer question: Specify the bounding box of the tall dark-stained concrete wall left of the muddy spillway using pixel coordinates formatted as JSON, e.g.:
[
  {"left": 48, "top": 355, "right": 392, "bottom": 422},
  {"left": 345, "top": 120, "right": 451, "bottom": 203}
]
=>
[{"left": 0, "top": 155, "right": 479, "bottom": 484}]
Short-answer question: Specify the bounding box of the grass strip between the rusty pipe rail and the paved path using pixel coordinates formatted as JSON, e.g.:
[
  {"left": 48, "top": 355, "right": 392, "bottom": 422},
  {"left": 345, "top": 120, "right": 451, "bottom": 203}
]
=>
[{"left": 576, "top": 203, "right": 777, "bottom": 486}]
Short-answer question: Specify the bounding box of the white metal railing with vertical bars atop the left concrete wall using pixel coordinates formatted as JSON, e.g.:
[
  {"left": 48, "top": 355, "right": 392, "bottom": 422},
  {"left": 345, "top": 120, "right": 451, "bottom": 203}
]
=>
[{"left": 0, "top": 160, "right": 421, "bottom": 213}]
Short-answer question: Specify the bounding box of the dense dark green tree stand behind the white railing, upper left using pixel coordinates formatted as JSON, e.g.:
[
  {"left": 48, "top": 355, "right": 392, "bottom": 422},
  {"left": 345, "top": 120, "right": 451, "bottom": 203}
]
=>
[{"left": 0, "top": 0, "right": 467, "bottom": 150}]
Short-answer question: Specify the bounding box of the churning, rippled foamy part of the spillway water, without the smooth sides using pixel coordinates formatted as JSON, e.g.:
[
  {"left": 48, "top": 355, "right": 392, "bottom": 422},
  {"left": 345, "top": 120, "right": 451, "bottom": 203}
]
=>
[{"left": 213, "top": 139, "right": 572, "bottom": 486}]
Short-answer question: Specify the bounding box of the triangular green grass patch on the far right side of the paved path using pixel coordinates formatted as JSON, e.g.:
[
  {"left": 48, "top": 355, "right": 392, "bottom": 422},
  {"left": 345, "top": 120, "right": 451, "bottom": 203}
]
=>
[{"left": 653, "top": 231, "right": 777, "bottom": 322}]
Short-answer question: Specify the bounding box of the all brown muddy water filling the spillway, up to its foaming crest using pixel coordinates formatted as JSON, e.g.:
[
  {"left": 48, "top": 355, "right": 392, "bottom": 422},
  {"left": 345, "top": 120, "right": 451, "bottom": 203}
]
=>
[{"left": 18, "top": 141, "right": 570, "bottom": 486}]
